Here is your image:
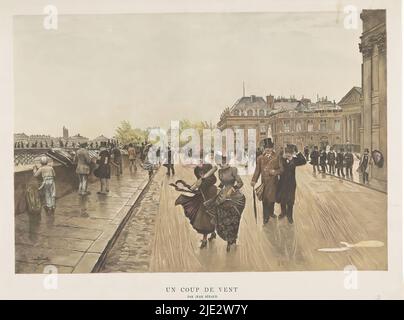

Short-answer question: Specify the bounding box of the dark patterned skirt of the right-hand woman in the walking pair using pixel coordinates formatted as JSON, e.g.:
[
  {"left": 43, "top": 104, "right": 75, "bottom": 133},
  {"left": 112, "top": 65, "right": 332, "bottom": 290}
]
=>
[{"left": 207, "top": 188, "right": 246, "bottom": 242}]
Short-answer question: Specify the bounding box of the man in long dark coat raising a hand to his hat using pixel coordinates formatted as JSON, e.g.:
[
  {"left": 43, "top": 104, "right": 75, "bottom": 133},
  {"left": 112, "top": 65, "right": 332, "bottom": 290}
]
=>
[{"left": 276, "top": 145, "right": 306, "bottom": 224}]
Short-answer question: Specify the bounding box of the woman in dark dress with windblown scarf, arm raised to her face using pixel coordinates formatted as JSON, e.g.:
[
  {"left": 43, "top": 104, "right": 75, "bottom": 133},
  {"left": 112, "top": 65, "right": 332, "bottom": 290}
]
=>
[{"left": 172, "top": 164, "right": 217, "bottom": 249}]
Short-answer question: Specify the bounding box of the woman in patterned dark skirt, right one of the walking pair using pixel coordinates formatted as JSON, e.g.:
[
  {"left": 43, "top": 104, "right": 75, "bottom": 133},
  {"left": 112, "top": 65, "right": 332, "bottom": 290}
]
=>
[{"left": 206, "top": 157, "right": 245, "bottom": 252}]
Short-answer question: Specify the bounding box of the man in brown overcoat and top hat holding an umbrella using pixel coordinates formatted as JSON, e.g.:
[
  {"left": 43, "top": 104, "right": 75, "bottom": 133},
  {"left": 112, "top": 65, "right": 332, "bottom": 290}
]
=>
[{"left": 251, "top": 138, "right": 283, "bottom": 224}]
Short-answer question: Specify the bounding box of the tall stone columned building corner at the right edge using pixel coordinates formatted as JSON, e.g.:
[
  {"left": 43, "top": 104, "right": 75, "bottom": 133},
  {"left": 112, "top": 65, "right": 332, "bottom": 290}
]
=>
[{"left": 359, "top": 10, "right": 387, "bottom": 189}]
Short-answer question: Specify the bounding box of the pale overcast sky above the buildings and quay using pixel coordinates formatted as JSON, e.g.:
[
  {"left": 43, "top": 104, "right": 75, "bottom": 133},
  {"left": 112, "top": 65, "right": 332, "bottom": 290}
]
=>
[{"left": 14, "top": 13, "right": 361, "bottom": 138}]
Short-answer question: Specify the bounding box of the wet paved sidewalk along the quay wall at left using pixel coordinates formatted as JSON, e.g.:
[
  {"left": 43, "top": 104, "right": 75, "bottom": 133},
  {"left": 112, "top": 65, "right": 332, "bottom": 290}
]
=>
[{"left": 15, "top": 169, "right": 149, "bottom": 273}]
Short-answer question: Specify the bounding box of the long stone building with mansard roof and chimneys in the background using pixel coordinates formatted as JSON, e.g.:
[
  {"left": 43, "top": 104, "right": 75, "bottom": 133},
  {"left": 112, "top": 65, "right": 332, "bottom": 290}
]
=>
[{"left": 217, "top": 95, "right": 344, "bottom": 150}]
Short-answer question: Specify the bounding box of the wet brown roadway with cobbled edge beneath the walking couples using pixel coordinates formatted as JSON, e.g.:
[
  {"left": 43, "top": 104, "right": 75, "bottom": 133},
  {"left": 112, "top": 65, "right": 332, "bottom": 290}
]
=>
[{"left": 102, "top": 165, "right": 387, "bottom": 272}]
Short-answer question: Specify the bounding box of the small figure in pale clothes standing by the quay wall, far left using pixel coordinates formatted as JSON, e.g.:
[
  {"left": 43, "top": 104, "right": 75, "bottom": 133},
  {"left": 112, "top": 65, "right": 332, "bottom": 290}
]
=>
[{"left": 34, "top": 156, "right": 56, "bottom": 215}]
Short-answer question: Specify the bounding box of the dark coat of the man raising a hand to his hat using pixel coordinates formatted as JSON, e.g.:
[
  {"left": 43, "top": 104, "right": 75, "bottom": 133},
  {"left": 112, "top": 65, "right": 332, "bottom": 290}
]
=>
[{"left": 276, "top": 152, "right": 306, "bottom": 204}]
